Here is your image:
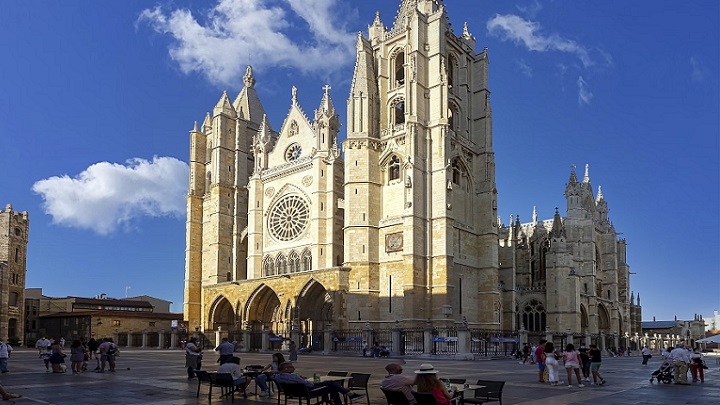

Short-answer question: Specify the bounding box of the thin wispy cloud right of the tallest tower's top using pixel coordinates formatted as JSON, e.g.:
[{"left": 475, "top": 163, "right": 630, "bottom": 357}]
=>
[{"left": 487, "top": 14, "right": 594, "bottom": 67}]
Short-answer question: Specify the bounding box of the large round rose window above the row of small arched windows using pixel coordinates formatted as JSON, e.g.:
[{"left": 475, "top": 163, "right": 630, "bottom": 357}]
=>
[{"left": 268, "top": 195, "right": 310, "bottom": 242}]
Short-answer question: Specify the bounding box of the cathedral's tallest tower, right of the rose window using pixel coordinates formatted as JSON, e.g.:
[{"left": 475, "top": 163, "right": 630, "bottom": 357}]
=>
[{"left": 343, "top": 0, "right": 502, "bottom": 327}]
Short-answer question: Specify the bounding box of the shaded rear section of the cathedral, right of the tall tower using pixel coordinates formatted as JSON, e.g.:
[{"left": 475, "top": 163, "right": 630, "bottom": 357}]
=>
[{"left": 499, "top": 166, "right": 642, "bottom": 347}]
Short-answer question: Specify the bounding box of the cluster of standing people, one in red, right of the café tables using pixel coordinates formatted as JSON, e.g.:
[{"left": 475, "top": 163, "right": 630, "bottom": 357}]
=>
[{"left": 533, "top": 339, "right": 605, "bottom": 388}]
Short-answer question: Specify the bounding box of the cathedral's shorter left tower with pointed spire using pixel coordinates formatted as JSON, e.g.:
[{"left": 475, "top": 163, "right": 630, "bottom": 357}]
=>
[{"left": 184, "top": 67, "right": 265, "bottom": 326}]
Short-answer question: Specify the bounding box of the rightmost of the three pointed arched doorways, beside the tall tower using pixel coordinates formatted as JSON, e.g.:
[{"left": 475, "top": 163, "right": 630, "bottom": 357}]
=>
[{"left": 296, "top": 280, "right": 333, "bottom": 350}]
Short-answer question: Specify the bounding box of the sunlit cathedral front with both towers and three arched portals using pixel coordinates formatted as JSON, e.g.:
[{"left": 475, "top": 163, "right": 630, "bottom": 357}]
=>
[{"left": 184, "top": 0, "right": 640, "bottom": 344}]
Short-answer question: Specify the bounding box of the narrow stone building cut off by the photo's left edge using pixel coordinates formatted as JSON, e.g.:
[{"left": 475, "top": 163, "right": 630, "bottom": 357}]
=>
[{"left": 0, "top": 204, "right": 30, "bottom": 342}]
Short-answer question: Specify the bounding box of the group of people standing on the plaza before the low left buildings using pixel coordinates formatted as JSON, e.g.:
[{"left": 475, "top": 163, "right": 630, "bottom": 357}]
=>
[{"left": 35, "top": 337, "right": 119, "bottom": 374}]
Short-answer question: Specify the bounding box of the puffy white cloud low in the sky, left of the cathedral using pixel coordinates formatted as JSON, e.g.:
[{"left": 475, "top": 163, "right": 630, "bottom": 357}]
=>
[{"left": 32, "top": 157, "right": 189, "bottom": 235}]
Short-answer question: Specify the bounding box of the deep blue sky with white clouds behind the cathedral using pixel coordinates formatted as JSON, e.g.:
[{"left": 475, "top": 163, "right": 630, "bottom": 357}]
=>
[{"left": 0, "top": 0, "right": 720, "bottom": 320}]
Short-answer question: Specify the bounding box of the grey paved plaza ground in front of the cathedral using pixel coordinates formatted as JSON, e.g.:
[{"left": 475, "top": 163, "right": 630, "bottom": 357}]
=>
[{"left": 0, "top": 348, "right": 720, "bottom": 405}]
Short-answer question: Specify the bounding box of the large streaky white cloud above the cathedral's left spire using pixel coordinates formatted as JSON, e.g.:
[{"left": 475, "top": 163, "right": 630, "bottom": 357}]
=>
[{"left": 138, "top": 0, "right": 356, "bottom": 85}]
